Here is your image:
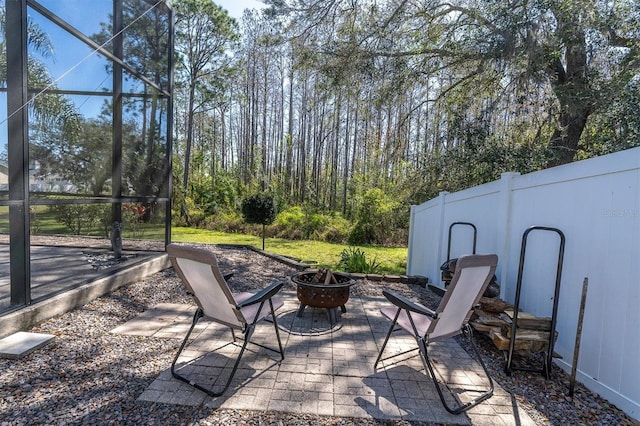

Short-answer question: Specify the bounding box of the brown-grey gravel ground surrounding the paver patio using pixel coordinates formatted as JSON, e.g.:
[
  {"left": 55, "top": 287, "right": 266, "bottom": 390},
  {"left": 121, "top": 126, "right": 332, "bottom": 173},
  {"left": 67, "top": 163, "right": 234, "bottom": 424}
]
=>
[{"left": 0, "top": 240, "right": 640, "bottom": 426}]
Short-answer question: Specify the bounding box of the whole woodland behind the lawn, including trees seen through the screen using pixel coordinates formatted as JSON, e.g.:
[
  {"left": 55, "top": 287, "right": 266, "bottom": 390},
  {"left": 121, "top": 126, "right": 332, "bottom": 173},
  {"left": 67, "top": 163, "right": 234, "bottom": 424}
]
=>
[{"left": 0, "top": 0, "right": 640, "bottom": 243}]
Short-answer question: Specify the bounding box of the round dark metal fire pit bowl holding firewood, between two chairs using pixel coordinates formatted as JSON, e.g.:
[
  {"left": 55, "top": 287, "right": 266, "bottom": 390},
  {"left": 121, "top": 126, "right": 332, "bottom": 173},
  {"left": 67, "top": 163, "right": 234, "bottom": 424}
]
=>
[{"left": 291, "top": 269, "right": 356, "bottom": 323}]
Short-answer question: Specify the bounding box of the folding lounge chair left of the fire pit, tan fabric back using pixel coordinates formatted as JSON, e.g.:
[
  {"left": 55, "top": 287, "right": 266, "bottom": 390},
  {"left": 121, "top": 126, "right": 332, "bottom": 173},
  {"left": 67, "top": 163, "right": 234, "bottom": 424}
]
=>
[{"left": 167, "top": 244, "right": 284, "bottom": 397}]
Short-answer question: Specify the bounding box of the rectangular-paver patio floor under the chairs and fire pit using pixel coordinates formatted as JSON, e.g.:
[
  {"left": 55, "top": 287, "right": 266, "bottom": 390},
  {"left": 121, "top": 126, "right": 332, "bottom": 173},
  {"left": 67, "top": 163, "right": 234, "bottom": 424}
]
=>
[{"left": 112, "top": 292, "right": 535, "bottom": 425}]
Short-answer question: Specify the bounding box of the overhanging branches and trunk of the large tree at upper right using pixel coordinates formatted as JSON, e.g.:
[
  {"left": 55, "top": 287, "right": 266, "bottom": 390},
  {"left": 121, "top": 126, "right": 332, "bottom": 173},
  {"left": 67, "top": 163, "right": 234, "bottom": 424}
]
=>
[{"left": 268, "top": 0, "right": 640, "bottom": 165}]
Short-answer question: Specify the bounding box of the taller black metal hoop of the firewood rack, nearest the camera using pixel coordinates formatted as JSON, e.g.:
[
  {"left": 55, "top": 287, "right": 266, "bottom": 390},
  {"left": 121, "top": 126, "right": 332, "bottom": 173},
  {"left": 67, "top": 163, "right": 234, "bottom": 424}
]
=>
[{"left": 504, "top": 226, "right": 565, "bottom": 379}]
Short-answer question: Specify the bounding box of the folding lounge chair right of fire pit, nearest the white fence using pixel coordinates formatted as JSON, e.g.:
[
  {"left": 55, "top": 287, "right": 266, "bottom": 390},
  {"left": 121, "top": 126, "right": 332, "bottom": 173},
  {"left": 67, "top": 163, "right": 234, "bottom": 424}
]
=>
[{"left": 374, "top": 254, "right": 498, "bottom": 414}]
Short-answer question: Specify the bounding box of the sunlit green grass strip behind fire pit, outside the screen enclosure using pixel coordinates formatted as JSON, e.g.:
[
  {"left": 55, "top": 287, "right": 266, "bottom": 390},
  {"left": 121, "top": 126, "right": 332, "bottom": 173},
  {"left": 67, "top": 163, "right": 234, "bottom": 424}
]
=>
[{"left": 171, "top": 227, "right": 407, "bottom": 275}]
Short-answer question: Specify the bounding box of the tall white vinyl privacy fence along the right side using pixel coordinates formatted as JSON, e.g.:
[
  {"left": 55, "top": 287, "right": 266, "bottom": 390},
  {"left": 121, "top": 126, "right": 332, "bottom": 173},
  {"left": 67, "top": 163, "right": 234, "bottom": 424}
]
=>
[{"left": 407, "top": 148, "right": 640, "bottom": 419}]
